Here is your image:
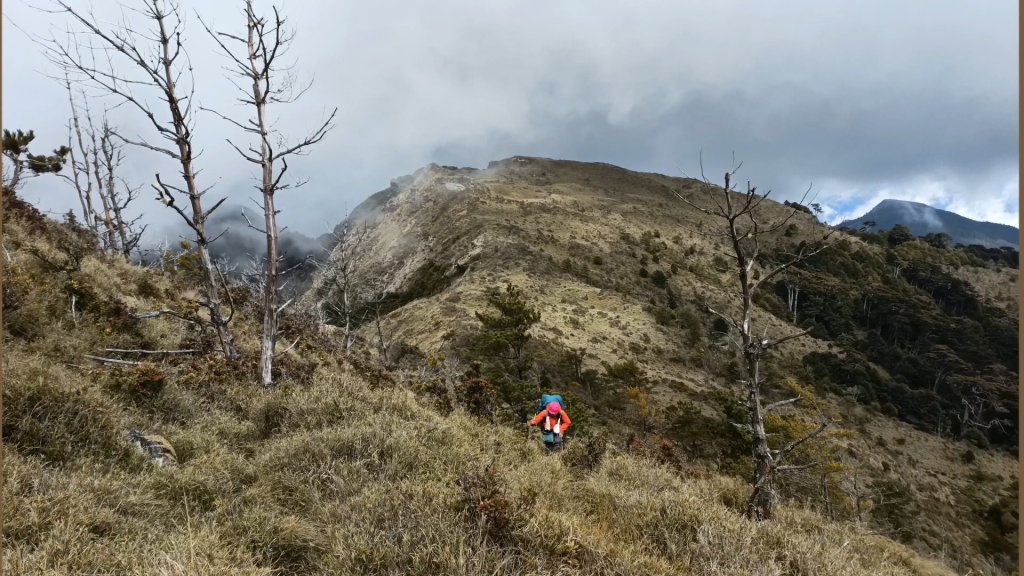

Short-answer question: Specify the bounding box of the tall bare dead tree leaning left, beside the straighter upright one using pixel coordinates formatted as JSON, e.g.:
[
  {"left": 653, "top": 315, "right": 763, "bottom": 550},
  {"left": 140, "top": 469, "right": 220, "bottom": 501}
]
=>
[{"left": 43, "top": 0, "right": 239, "bottom": 359}]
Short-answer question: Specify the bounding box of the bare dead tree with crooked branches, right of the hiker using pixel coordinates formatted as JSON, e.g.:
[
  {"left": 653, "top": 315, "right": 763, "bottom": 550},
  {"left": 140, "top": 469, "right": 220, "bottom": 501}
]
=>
[{"left": 676, "top": 158, "right": 834, "bottom": 520}]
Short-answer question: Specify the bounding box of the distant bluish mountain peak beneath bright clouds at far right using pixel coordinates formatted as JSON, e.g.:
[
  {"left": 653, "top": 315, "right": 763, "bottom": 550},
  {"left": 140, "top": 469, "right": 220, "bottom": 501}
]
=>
[{"left": 839, "top": 198, "right": 1020, "bottom": 249}]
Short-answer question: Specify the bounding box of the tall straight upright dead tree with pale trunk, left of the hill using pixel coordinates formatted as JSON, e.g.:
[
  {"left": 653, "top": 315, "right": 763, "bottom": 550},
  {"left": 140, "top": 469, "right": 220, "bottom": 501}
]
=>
[{"left": 203, "top": 0, "right": 338, "bottom": 387}]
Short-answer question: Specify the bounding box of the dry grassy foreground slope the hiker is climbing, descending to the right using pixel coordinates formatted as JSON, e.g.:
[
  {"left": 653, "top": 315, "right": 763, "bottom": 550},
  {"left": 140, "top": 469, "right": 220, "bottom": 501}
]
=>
[{"left": 3, "top": 194, "right": 962, "bottom": 575}]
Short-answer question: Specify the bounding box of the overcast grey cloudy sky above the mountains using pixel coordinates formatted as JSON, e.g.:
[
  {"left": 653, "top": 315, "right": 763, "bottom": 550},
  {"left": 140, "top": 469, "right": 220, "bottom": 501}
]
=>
[{"left": 3, "top": 0, "right": 1019, "bottom": 239}]
